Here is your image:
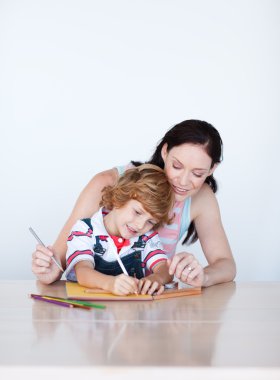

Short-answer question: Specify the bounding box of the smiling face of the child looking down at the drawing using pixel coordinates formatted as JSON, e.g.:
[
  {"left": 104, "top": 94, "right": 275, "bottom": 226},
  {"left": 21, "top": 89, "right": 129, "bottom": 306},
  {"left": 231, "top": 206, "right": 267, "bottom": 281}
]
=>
[{"left": 110, "top": 199, "right": 158, "bottom": 239}]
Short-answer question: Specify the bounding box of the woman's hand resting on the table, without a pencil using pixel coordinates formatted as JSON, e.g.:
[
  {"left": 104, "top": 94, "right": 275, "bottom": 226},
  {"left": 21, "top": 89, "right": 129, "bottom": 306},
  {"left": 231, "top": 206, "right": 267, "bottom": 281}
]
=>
[{"left": 167, "top": 252, "right": 205, "bottom": 286}]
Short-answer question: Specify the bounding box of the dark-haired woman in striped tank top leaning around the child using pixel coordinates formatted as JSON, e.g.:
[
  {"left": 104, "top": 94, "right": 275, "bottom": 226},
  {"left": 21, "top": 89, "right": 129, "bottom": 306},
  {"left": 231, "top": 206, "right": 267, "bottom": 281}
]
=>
[{"left": 32, "top": 120, "right": 236, "bottom": 287}]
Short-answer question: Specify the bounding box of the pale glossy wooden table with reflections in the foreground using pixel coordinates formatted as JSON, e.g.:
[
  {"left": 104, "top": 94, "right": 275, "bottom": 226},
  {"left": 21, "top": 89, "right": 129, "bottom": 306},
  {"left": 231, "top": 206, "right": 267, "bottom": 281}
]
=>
[{"left": 0, "top": 281, "right": 280, "bottom": 380}]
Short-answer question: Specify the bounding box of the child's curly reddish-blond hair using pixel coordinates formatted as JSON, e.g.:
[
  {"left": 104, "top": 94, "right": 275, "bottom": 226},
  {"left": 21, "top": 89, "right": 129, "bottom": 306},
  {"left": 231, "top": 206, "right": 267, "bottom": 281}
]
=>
[{"left": 100, "top": 164, "right": 174, "bottom": 229}]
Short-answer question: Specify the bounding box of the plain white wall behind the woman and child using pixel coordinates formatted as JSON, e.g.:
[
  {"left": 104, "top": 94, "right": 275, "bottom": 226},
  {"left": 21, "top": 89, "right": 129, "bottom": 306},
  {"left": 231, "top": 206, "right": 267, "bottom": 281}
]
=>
[{"left": 0, "top": 0, "right": 280, "bottom": 281}]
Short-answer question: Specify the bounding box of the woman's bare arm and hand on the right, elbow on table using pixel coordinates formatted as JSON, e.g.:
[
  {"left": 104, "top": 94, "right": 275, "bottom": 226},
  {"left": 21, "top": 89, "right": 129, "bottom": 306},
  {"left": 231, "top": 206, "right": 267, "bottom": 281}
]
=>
[{"left": 169, "top": 184, "right": 236, "bottom": 287}]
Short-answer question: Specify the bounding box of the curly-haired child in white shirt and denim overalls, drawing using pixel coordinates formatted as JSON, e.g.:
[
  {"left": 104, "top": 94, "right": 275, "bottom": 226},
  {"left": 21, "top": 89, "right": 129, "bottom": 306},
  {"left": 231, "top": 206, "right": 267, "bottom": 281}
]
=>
[{"left": 66, "top": 164, "right": 174, "bottom": 295}]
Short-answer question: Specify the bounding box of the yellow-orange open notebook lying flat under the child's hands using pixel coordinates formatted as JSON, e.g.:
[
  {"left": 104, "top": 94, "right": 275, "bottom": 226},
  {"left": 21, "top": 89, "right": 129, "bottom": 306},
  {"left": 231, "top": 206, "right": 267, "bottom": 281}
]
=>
[{"left": 66, "top": 281, "right": 201, "bottom": 301}]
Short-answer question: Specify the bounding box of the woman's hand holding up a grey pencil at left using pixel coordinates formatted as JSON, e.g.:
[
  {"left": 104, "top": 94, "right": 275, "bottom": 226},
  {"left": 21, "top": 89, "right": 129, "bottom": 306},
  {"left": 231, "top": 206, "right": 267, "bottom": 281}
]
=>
[{"left": 32, "top": 244, "right": 62, "bottom": 284}]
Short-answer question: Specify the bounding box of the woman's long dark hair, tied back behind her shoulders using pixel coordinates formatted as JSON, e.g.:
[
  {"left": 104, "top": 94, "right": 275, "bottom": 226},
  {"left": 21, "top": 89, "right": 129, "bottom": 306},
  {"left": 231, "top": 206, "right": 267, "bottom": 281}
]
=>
[{"left": 131, "top": 120, "right": 223, "bottom": 244}]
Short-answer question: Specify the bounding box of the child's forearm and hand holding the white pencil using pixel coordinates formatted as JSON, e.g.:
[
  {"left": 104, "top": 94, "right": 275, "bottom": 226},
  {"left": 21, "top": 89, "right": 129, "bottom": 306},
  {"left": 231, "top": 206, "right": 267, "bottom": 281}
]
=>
[{"left": 75, "top": 261, "right": 138, "bottom": 296}]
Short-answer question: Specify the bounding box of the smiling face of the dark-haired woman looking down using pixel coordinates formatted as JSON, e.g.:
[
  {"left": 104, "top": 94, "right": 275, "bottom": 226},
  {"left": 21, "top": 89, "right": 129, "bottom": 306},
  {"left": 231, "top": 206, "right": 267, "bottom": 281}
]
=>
[{"left": 161, "top": 144, "right": 217, "bottom": 201}]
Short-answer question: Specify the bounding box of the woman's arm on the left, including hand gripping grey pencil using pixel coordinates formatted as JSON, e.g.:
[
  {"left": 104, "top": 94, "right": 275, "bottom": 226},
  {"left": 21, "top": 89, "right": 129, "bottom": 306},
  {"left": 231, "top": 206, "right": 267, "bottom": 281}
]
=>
[{"left": 32, "top": 169, "right": 118, "bottom": 284}]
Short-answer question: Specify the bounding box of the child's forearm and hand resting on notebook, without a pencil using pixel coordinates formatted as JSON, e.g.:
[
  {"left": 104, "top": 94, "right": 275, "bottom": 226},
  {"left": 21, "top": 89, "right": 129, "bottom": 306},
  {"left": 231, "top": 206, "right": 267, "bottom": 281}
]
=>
[{"left": 138, "top": 260, "right": 173, "bottom": 294}]
